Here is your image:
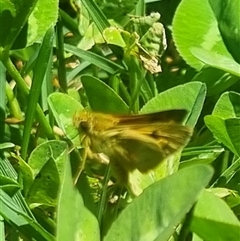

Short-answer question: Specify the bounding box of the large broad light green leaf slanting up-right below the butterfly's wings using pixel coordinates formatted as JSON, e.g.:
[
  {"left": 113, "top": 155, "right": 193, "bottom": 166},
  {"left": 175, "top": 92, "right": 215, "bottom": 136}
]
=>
[{"left": 104, "top": 165, "right": 213, "bottom": 241}]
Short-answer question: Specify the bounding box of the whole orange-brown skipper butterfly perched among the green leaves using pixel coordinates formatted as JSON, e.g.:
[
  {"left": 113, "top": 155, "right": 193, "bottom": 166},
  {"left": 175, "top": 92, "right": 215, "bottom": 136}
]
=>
[{"left": 73, "top": 109, "right": 192, "bottom": 185}]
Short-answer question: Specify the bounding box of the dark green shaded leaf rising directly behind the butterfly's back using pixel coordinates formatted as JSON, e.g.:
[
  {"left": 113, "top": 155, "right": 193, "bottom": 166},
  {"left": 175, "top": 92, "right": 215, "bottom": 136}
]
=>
[{"left": 81, "top": 75, "right": 128, "bottom": 113}]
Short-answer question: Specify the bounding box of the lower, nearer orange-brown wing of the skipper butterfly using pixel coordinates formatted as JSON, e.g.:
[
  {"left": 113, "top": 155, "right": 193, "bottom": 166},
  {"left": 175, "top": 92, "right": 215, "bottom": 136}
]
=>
[{"left": 106, "top": 123, "right": 192, "bottom": 172}]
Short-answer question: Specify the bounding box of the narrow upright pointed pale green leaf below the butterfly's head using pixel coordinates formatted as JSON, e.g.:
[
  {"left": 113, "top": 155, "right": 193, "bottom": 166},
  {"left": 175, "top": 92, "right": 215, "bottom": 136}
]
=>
[{"left": 56, "top": 149, "right": 100, "bottom": 241}]
